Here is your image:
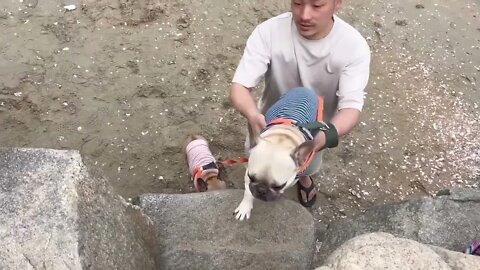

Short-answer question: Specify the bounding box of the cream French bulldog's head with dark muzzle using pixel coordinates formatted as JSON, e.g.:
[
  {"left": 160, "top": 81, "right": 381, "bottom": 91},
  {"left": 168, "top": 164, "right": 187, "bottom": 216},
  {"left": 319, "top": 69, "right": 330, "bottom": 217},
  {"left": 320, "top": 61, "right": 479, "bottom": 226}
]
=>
[{"left": 246, "top": 140, "right": 314, "bottom": 201}]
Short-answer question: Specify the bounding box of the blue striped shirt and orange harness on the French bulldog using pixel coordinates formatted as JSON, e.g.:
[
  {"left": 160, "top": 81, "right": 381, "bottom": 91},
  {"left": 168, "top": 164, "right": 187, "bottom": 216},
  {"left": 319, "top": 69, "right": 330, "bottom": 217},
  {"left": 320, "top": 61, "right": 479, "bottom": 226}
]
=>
[{"left": 262, "top": 87, "right": 338, "bottom": 175}]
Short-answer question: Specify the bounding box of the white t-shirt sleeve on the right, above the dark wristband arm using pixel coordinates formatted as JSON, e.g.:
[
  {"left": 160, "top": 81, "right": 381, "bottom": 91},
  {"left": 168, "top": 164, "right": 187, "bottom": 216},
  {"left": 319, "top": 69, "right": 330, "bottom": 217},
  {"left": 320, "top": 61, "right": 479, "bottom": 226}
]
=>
[{"left": 337, "top": 50, "right": 370, "bottom": 111}]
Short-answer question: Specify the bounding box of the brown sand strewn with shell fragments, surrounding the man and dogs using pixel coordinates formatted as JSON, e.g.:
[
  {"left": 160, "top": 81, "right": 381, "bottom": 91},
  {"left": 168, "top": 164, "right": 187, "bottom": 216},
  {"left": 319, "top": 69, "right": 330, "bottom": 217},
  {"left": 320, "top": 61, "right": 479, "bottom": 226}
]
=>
[{"left": 0, "top": 0, "right": 480, "bottom": 223}]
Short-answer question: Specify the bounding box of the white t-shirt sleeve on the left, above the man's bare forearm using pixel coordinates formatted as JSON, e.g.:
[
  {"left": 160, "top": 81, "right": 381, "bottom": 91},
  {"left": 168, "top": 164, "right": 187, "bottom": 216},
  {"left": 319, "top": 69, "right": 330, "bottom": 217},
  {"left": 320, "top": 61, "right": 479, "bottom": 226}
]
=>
[{"left": 232, "top": 25, "right": 272, "bottom": 88}]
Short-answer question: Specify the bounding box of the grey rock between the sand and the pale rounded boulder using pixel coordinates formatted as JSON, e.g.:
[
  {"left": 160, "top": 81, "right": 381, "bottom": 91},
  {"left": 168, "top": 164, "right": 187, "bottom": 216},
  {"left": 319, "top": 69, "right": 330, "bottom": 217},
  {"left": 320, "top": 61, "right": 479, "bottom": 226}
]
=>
[{"left": 316, "top": 189, "right": 480, "bottom": 264}]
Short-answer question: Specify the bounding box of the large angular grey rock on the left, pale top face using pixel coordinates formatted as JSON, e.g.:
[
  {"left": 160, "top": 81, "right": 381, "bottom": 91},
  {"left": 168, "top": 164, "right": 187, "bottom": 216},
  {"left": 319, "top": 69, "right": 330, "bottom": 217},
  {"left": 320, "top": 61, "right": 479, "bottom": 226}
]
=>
[{"left": 0, "top": 148, "right": 155, "bottom": 269}]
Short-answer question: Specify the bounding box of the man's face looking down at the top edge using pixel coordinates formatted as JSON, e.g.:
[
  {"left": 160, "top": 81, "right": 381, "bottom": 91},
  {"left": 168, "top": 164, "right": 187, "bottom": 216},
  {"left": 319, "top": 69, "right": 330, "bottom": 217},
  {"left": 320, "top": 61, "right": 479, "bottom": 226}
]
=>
[{"left": 292, "top": 0, "right": 342, "bottom": 39}]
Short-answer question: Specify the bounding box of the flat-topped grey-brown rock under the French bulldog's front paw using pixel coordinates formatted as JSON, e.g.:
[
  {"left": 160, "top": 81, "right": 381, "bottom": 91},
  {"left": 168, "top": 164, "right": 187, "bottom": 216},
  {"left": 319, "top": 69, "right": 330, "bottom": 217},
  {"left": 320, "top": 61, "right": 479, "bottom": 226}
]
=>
[{"left": 139, "top": 190, "right": 315, "bottom": 269}]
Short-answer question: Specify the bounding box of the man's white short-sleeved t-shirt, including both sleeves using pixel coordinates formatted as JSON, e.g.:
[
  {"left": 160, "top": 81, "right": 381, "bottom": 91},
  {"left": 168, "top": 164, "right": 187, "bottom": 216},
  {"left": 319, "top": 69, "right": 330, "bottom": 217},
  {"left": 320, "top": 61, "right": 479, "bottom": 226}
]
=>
[{"left": 233, "top": 12, "right": 370, "bottom": 121}]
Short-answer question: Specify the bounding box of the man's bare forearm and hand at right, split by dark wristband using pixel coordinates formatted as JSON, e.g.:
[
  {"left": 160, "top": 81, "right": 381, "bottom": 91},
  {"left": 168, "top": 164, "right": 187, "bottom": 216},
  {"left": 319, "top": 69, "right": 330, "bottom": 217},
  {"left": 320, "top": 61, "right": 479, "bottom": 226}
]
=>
[{"left": 314, "top": 108, "right": 360, "bottom": 151}]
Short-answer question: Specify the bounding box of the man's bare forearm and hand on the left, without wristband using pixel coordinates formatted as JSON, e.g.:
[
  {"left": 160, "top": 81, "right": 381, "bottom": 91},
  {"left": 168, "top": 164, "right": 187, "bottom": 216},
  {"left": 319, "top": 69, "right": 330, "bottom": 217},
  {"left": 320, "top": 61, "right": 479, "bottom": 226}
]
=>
[{"left": 230, "top": 83, "right": 266, "bottom": 133}]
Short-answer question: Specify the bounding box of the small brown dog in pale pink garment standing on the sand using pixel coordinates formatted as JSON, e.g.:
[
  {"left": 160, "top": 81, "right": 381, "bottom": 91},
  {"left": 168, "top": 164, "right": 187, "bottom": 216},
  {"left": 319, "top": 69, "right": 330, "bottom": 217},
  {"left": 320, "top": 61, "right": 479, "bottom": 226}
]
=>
[{"left": 184, "top": 135, "right": 227, "bottom": 192}]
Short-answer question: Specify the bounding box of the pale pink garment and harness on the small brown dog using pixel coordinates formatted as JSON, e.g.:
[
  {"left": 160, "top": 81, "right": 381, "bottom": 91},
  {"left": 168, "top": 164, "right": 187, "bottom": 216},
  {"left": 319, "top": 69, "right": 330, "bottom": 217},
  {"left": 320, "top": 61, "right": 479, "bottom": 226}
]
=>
[{"left": 186, "top": 139, "right": 218, "bottom": 191}]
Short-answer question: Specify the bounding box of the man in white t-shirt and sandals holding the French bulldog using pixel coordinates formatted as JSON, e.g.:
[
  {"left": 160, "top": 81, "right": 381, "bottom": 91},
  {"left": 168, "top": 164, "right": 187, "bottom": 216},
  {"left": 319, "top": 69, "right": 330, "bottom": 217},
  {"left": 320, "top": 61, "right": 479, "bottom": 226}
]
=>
[{"left": 230, "top": 0, "right": 370, "bottom": 207}]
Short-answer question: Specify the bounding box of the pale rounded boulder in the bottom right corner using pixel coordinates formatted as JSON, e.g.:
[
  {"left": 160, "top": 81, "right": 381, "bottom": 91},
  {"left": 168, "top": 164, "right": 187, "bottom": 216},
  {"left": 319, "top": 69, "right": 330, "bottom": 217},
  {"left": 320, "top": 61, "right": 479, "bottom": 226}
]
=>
[{"left": 317, "top": 233, "right": 480, "bottom": 270}]
